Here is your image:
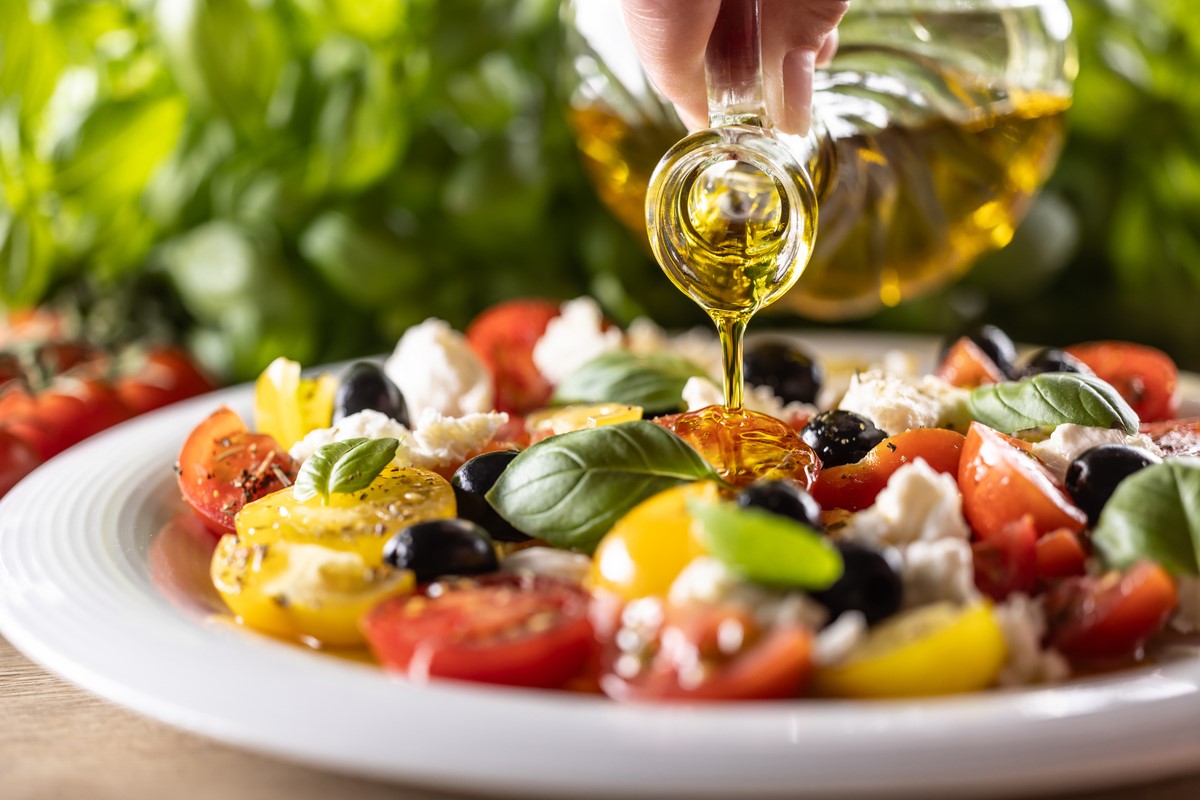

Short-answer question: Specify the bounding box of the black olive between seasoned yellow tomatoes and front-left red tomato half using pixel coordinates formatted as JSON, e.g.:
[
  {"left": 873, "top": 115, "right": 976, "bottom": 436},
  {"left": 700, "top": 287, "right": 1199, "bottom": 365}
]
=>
[{"left": 383, "top": 519, "right": 499, "bottom": 583}]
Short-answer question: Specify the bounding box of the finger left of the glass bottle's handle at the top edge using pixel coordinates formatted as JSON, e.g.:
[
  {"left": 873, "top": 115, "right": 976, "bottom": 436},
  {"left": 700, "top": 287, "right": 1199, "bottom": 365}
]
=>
[{"left": 622, "top": 0, "right": 721, "bottom": 130}]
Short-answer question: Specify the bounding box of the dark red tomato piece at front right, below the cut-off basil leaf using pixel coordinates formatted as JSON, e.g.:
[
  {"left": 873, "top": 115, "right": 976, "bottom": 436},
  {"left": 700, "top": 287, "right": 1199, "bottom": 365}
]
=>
[{"left": 1046, "top": 561, "right": 1178, "bottom": 661}]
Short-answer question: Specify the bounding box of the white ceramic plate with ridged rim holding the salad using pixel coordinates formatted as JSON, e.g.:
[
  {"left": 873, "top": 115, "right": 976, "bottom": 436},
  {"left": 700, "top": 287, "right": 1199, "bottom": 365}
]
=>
[{"left": 0, "top": 336, "right": 1200, "bottom": 798}]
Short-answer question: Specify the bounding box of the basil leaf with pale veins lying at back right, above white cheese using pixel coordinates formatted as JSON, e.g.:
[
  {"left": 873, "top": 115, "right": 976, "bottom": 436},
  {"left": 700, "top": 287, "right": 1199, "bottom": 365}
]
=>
[{"left": 967, "top": 372, "right": 1138, "bottom": 434}]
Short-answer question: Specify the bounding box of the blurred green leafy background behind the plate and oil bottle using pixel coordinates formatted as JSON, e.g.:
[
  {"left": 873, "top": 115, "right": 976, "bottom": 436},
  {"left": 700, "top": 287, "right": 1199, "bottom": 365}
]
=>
[{"left": 0, "top": 0, "right": 1200, "bottom": 379}]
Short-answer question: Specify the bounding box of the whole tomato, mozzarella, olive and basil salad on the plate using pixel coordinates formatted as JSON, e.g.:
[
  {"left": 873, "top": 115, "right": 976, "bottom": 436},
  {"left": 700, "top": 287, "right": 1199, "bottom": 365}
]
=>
[{"left": 171, "top": 299, "right": 1200, "bottom": 700}]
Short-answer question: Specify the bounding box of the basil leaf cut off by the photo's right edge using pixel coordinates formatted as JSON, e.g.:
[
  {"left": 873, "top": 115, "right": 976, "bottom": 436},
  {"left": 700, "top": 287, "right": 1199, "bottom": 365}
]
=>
[{"left": 1092, "top": 458, "right": 1200, "bottom": 576}]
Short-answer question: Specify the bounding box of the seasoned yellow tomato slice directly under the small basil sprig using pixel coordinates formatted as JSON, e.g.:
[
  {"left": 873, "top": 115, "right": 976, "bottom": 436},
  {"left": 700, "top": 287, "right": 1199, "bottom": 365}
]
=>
[{"left": 235, "top": 467, "right": 456, "bottom": 567}]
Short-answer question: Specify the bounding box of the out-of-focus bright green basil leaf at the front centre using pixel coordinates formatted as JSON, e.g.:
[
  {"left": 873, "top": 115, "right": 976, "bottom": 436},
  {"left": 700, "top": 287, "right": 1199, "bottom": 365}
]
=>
[{"left": 688, "top": 500, "right": 844, "bottom": 589}]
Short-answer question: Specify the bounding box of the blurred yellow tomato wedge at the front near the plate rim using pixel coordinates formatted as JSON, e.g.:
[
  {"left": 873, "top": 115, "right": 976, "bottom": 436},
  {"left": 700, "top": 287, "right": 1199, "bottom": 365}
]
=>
[{"left": 812, "top": 602, "right": 1008, "bottom": 698}]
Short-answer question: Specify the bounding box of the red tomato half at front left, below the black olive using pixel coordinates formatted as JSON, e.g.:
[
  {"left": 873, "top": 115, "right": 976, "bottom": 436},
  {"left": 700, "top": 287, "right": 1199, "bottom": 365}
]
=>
[{"left": 362, "top": 575, "right": 596, "bottom": 688}]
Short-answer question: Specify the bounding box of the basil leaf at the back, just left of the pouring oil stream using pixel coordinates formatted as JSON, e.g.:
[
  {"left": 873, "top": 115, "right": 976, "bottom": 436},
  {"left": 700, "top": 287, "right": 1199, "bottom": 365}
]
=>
[{"left": 553, "top": 350, "right": 704, "bottom": 411}]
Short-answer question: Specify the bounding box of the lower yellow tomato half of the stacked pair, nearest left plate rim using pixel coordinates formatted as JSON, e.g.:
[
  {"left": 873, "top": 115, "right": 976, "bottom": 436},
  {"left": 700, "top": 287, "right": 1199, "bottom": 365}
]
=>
[{"left": 211, "top": 534, "right": 414, "bottom": 648}]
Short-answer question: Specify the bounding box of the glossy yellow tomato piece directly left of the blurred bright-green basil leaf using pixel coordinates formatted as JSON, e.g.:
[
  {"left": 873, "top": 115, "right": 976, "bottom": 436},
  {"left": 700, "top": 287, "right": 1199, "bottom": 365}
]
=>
[{"left": 589, "top": 481, "right": 720, "bottom": 600}]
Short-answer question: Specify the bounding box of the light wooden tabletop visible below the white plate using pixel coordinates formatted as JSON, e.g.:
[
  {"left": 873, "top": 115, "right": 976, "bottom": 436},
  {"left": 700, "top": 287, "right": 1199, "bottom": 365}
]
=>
[{"left": 0, "top": 638, "right": 1200, "bottom": 800}]
